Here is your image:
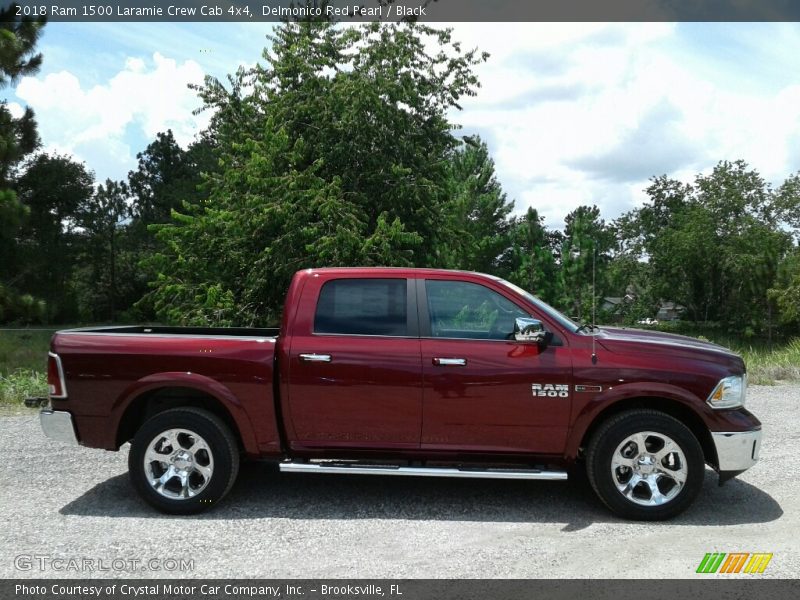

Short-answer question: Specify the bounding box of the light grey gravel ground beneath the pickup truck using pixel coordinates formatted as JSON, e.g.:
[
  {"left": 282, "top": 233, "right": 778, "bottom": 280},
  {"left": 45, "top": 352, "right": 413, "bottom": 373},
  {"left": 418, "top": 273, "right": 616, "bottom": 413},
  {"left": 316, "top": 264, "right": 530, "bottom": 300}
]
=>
[{"left": 0, "top": 384, "right": 800, "bottom": 578}]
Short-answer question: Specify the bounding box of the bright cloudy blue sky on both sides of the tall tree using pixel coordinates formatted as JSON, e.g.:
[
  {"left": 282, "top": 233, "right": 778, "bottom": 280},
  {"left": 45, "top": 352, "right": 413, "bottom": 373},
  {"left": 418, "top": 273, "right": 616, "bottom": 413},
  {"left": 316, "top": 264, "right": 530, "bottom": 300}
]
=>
[{"left": 5, "top": 23, "right": 800, "bottom": 227}]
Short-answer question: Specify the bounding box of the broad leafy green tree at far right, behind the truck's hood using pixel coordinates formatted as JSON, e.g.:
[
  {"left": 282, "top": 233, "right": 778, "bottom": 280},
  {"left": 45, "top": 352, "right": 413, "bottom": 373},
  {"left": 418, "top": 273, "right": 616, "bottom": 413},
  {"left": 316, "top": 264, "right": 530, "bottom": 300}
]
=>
[{"left": 626, "top": 161, "right": 791, "bottom": 333}]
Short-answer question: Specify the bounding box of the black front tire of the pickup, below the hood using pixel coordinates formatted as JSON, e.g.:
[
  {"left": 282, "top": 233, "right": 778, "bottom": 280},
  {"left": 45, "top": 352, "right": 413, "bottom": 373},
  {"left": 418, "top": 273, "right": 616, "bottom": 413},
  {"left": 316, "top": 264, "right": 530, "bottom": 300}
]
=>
[{"left": 586, "top": 410, "right": 705, "bottom": 521}]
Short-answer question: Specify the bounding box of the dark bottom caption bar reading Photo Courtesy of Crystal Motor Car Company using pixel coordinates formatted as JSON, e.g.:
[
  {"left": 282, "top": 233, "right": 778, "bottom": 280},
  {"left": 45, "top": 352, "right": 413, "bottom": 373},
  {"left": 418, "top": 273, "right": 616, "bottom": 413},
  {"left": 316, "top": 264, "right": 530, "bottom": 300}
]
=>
[{"left": 0, "top": 576, "right": 800, "bottom": 600}]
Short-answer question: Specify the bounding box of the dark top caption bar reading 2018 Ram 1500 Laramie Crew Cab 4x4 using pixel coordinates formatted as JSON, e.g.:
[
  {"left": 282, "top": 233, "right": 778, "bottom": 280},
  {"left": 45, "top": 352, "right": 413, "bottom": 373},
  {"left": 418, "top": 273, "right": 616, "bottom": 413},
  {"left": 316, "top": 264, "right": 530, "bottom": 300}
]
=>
[{"left": 0, "top": 0, "right": 800, "bottom": 23}]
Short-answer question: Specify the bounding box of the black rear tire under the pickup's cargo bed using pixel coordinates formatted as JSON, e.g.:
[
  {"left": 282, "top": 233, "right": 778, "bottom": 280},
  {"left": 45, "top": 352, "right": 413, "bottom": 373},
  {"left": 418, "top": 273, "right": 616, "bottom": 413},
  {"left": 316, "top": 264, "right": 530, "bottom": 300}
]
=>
[{"left": 128, "top": 408, "right": 239, "bottom": 515}]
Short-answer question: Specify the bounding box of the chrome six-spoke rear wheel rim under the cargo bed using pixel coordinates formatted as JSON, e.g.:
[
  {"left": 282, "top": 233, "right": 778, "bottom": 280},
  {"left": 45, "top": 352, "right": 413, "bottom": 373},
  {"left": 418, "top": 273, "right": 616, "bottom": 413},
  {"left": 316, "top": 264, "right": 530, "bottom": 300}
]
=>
[{"left": 144, "top": 429, "right": 214, "bottom": 500}]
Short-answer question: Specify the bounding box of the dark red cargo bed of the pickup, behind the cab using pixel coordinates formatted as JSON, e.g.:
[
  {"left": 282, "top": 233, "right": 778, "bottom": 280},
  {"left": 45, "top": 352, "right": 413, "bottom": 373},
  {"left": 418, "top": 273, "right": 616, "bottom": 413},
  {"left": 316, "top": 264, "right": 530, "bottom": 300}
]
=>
[{"left": 51, "top": 325, "right": 280, "bottom": 455}]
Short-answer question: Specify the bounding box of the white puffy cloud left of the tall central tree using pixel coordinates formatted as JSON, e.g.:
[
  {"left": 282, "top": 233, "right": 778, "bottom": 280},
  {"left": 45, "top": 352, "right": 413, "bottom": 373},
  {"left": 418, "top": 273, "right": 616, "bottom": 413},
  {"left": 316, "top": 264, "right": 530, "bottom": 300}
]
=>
[{"left": 16, "top": 53, "right": 209, "bottom": 177}]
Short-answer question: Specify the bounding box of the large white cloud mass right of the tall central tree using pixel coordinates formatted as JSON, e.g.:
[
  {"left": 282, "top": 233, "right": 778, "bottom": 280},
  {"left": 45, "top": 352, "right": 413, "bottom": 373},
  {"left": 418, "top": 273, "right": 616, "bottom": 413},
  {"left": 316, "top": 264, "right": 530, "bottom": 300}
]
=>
[{"left": 452, "top": 23, "right": 800, "bottom": 227}]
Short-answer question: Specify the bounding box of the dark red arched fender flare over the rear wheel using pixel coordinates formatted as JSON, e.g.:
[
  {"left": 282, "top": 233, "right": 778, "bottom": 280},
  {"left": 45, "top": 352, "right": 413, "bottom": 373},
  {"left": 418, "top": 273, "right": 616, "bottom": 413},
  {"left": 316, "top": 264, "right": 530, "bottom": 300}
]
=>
[{"left": 110, "top": 371, "right": 258, "bottom": 454}]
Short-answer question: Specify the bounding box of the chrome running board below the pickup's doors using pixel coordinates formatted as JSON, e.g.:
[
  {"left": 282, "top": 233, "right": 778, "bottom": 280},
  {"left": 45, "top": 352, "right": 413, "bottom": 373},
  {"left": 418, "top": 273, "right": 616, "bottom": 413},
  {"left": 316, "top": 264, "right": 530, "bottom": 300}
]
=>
[{"left": 280, "top": 461, "right": 567, "bottom": 481}]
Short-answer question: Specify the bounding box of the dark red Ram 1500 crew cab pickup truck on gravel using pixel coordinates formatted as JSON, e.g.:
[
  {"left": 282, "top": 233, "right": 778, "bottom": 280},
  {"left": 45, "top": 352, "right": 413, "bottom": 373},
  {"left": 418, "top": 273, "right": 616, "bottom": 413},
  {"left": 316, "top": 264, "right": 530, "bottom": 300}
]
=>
[{"left": 41, "top": 268, "right": 761, "bottom": 519}]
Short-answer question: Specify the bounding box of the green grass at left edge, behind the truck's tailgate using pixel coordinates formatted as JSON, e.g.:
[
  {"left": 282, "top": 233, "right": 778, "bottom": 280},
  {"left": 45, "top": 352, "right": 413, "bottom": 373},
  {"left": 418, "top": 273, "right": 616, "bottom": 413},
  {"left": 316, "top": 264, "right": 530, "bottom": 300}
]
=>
[{"left": 0, "top": 329, "right": 55, "bottom": 405}]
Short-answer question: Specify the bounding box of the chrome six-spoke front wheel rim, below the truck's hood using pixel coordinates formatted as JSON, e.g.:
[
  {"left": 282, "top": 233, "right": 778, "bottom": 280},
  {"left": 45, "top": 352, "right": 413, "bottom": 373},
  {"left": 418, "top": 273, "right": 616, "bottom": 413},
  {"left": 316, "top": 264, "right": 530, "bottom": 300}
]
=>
[{"left": 611, "top": 431, "right": 688, "bottom": 506}]
